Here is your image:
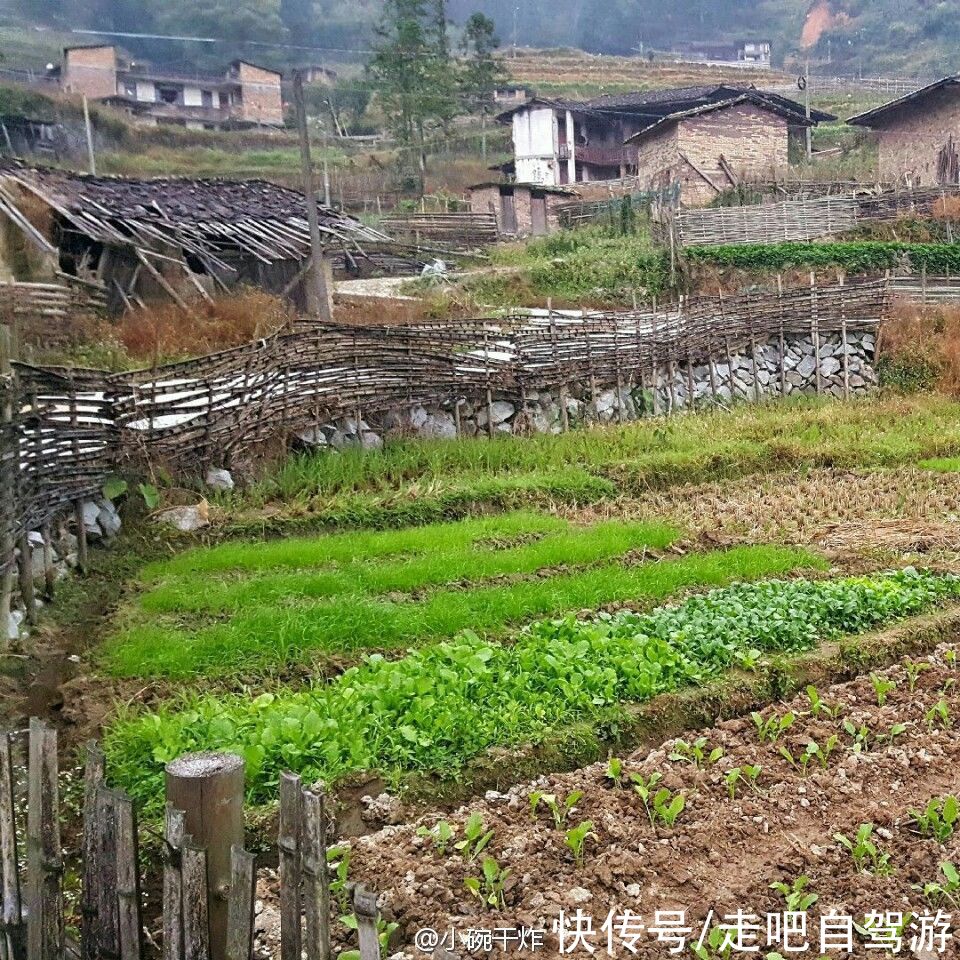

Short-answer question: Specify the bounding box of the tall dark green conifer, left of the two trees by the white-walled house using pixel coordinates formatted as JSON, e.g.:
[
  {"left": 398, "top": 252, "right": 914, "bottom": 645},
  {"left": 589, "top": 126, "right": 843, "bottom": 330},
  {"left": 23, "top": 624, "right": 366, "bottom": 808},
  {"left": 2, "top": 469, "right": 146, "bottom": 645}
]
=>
[{"left": 367, "top": 0, "right": 456, "bottom": 190}]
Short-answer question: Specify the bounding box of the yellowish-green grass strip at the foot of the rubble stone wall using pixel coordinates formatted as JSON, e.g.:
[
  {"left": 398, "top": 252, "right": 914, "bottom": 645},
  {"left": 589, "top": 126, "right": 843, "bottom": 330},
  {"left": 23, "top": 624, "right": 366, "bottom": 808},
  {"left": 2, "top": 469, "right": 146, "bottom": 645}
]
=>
[{"left": 232, "top": 395, "right": 960, "bottom": 531}]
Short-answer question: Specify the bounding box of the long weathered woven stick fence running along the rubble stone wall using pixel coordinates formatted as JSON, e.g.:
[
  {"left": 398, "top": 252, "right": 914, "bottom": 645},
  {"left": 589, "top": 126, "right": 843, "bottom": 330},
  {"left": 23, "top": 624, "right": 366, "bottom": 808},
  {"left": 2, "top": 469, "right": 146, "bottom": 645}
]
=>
[{"left": 0, "top": 281, "right": 889, "bottom": 592}]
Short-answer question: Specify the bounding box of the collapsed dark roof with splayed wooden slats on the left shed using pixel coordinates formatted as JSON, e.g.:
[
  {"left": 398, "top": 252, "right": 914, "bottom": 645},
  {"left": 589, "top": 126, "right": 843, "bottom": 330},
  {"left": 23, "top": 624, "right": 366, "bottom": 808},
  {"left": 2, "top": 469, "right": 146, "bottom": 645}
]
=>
[{"left": 0, "top": 160, "right": 389, "bottom": 265}]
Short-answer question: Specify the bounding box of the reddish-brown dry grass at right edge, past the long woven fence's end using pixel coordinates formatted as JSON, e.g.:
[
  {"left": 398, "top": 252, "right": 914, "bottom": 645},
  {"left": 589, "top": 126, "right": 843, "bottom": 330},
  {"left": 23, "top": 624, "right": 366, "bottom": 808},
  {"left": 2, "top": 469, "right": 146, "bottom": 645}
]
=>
[{"left": 878, "top": 303, "right": 960, "bottom": 396}]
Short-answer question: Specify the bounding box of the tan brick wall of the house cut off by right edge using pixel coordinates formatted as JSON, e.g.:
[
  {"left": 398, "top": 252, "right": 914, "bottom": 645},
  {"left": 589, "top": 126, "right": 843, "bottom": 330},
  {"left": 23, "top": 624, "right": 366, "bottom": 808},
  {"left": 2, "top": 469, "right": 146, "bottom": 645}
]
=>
[{"left": 878, "top": 87, "right": 960, "bottom": 187}]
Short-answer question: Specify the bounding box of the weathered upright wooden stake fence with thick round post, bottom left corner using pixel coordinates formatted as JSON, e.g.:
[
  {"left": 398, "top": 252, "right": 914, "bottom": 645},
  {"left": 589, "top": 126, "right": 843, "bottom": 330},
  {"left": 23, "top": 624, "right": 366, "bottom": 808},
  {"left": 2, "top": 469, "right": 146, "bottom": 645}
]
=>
[{"left": 0, "top": 719, "right": 390, "bottom": 960}]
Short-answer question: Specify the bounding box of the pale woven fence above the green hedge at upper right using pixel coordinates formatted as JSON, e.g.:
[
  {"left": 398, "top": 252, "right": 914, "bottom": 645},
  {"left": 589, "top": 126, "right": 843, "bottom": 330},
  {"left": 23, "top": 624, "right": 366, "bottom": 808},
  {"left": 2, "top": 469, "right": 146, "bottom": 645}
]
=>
[{"left": 676, "top": 187, "right": 960, "bottom": 247}]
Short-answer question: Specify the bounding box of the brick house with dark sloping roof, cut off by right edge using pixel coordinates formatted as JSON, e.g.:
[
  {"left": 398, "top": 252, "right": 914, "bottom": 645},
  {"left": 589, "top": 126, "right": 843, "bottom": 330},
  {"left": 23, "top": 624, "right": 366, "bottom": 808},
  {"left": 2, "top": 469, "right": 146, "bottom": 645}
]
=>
[{"left": 847, "top": 74, "right": 960, "bottom": 187}]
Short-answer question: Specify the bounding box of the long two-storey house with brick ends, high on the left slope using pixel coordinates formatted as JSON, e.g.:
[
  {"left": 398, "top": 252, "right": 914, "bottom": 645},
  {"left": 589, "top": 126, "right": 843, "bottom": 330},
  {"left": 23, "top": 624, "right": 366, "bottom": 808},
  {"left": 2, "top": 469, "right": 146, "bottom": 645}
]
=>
[{"left": 60, "top": 45, "right": 283, "bottom": 129}]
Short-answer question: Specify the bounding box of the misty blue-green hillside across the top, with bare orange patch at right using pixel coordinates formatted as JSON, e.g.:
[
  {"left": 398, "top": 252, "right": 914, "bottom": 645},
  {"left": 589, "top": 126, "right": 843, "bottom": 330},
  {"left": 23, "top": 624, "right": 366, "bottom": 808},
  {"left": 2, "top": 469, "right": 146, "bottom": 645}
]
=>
[{"left": 0, "top": 0, "right": 960, "bottom": 75}]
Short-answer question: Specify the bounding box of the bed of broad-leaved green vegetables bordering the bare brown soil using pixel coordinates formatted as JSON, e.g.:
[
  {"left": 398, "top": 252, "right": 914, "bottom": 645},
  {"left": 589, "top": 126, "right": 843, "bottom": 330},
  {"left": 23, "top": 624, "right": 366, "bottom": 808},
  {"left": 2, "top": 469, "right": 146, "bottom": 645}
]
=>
[{"left": 106, "top": 568, "right": 960, "bottom": 809}]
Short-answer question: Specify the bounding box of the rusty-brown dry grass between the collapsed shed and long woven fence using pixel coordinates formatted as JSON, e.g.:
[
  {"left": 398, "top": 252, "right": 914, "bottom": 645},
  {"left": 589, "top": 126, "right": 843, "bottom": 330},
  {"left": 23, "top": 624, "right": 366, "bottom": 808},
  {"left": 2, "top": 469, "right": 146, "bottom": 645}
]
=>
[{"left": 115, "top": 289, "right": 294, "bottom": 362}]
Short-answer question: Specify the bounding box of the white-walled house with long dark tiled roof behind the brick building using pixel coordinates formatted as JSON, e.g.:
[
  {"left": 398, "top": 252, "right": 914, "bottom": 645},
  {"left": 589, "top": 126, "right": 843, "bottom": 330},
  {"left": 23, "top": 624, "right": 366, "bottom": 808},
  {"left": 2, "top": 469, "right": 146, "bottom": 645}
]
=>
[{"left": 497, "top": 84, "right": 834, "bottom": 186}]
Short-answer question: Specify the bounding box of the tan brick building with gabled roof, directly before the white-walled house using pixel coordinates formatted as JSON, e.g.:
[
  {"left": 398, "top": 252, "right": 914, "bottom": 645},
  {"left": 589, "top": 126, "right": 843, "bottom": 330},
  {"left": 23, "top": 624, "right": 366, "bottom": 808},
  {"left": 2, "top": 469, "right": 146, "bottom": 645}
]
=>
[{"left": 627, "top": 93, "right": 816, "bottom": 205}]
